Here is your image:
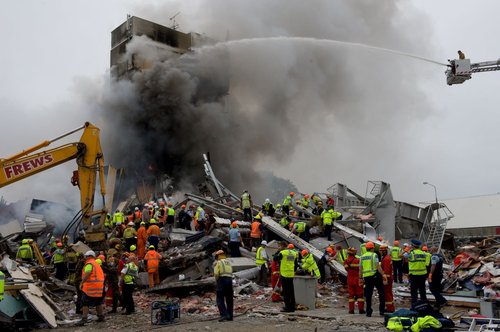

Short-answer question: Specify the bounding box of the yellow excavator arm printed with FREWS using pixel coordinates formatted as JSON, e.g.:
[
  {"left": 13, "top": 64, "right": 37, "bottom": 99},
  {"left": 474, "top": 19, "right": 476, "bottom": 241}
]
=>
[{"left": 0, "top": 122, "right": 107, "bottom": 243}]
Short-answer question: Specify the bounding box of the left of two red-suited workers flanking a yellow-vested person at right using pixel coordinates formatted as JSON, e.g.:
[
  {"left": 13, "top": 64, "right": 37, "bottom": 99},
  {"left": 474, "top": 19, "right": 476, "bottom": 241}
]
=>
[{"left": 344, "top": 247, "right": 365, "bottom": 314}]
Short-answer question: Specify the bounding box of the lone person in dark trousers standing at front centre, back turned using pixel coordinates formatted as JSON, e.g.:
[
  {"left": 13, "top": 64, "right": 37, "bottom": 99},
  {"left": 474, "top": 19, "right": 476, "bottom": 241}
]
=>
[{"left": 214, "top": 250, "right": 234, "bottom": 322}]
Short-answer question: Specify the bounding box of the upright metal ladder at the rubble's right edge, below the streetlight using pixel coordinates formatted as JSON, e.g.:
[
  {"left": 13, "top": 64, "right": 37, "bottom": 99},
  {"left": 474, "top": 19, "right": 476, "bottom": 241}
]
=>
[{"left": 419, "top": 203, "right": 454, "bottom": 252}]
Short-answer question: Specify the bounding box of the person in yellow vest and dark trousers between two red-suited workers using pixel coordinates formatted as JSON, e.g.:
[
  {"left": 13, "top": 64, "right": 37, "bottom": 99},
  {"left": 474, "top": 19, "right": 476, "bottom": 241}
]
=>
[{"left": 359, "top": 241, "right": 386, "bottom": 317}]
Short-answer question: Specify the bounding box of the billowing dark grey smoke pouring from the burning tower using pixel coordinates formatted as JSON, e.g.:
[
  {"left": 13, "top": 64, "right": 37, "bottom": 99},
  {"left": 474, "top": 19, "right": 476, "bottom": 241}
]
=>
[{"left": 97, "top": 1, "right": 434, "bottom": 199}]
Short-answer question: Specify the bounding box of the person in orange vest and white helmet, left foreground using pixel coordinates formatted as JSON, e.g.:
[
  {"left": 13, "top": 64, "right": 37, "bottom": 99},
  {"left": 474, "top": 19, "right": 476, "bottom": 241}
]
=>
[{"left": 76, "top": 250, "right": 105, "bottom": 326}]
